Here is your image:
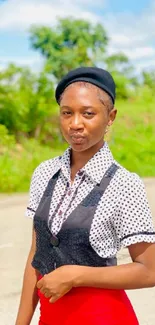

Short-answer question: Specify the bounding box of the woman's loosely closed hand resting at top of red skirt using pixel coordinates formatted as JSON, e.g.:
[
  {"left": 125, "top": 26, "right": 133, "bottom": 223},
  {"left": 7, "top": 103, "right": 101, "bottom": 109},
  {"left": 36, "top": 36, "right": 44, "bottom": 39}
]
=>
[{"left": 37, "top": 265, "right": 80, "bottom": 303}]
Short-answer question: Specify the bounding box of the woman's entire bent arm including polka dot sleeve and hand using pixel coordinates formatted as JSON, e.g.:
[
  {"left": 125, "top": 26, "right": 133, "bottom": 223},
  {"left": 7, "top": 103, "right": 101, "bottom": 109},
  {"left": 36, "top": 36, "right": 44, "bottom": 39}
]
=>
[{"left": 37, "top": 176, "right": 155, "bottom": 302}]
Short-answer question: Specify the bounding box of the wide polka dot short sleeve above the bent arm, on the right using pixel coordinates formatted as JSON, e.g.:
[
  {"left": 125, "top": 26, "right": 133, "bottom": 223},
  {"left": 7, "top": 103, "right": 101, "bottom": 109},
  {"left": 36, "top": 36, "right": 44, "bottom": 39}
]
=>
[{"left": 114, "top": 173, "right": 155, "bottom": 247}]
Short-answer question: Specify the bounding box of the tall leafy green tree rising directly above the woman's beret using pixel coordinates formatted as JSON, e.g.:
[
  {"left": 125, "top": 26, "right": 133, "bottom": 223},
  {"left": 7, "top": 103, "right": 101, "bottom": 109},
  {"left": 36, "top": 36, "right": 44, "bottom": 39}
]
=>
[{"left": 30, "top": 18, "right": 137, "bottom": 99}]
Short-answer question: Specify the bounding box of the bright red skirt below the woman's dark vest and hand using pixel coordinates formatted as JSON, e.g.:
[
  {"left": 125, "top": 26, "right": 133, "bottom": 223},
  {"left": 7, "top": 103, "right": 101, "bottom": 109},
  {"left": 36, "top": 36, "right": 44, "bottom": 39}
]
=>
[{"left": 38, "top": 280, "right": 139, "bottom": 325}]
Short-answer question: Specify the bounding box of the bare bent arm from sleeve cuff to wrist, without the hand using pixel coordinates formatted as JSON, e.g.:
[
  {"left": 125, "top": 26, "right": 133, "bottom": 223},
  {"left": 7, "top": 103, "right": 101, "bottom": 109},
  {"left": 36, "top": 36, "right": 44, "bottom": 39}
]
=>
[{"left": 73, "top": 242, "right": 155, "bottom": 290}]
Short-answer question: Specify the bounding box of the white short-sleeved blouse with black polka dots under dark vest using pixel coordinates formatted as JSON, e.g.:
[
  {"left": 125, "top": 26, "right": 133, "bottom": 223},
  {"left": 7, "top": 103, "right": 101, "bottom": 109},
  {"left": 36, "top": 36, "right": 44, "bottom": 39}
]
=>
[{"left": 26, "top": 143, "right": 155, "bottom": 258}]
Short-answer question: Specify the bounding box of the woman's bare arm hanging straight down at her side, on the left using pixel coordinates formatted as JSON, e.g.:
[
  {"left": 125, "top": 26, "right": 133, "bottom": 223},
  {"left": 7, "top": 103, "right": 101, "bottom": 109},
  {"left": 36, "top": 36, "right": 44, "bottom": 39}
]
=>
[{"left": 15, "top": 230, "right": 38, "bottom": 325}]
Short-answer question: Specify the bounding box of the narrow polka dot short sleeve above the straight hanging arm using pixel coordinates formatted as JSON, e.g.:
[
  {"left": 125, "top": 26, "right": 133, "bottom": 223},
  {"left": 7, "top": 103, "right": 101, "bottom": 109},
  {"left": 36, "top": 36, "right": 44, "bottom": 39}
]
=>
[{"left": 25, "top": 167, "right": 39, "bottom": 218}]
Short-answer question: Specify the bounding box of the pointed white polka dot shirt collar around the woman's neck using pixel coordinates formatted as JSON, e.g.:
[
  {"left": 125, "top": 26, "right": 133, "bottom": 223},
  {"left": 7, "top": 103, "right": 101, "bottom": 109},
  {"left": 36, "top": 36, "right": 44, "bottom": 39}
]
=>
[{"left": 60, "top": 142, "right": 114, "bottom": 183}]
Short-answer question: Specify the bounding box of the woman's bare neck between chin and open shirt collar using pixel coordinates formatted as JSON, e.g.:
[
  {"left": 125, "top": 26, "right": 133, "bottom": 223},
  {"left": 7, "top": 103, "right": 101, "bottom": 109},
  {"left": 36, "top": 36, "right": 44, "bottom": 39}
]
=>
[{"left": 71, "top": 140, "right": 104, "bottom": 171}]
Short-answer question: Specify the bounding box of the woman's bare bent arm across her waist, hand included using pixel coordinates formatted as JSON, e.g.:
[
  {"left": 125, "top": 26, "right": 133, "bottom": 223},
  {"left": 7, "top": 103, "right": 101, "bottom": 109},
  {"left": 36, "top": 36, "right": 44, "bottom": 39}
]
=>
[{"left": 37, "top": 242, "right": 155, "bottom": 303}]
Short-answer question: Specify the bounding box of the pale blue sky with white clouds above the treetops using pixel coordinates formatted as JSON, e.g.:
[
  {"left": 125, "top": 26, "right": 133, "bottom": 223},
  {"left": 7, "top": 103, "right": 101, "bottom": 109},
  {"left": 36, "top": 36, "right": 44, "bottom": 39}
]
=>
[{"left": 0, "top": 0, "right": 155, "bottom": 71}]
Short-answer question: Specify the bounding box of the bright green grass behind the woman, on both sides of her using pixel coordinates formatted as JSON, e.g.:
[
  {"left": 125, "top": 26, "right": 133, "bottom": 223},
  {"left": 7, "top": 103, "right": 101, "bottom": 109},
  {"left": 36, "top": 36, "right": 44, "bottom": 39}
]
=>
[{"left": 0, "top": 100, "right": 155, "bottom": 193}]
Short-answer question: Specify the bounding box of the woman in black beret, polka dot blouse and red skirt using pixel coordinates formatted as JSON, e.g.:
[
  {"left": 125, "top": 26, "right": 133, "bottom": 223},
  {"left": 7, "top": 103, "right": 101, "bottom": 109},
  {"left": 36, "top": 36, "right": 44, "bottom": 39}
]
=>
[{"left": 16, "top": 67, "right": 155, "bottom": 325}]
